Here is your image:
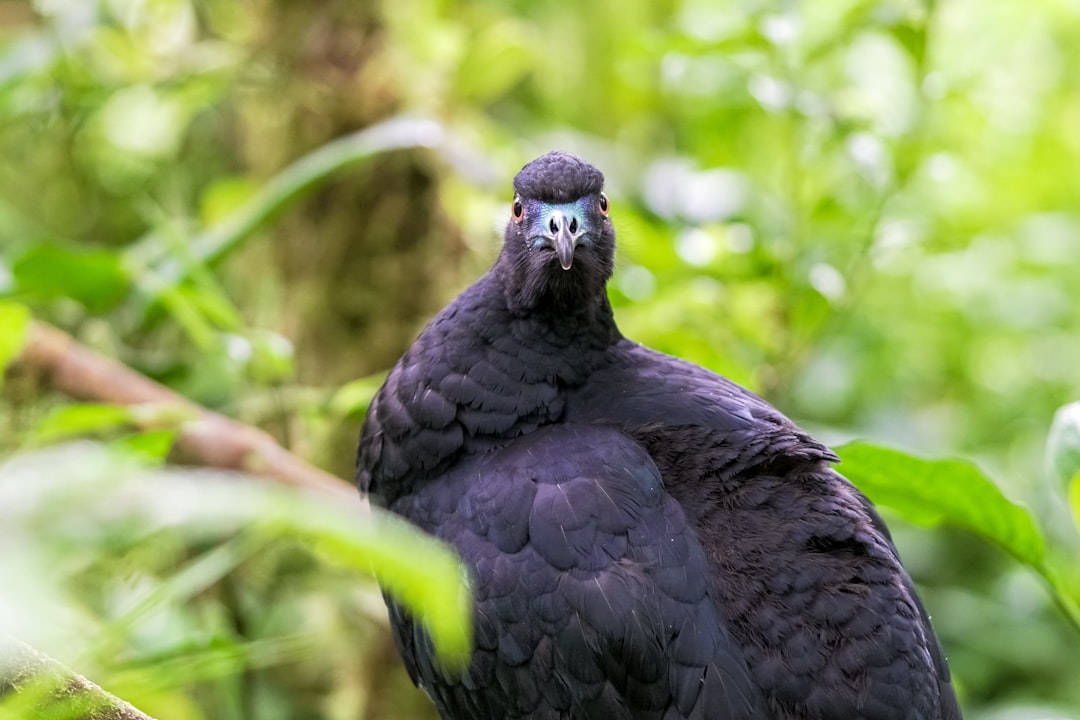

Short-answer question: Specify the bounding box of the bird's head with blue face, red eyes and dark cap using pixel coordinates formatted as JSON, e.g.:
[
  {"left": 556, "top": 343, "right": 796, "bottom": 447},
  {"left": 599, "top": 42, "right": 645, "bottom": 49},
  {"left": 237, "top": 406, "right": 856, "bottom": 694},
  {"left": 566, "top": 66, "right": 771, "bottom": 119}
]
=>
[{"left": 500, "top": 151, "right": 615, "bottom": 308}]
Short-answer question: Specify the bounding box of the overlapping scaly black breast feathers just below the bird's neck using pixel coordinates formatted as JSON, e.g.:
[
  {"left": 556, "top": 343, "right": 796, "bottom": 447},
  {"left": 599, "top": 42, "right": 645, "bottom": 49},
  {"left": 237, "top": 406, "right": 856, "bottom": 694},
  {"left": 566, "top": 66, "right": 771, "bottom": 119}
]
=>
[{"left": 357, "top": 297, "right": 622, "bottom": 502}]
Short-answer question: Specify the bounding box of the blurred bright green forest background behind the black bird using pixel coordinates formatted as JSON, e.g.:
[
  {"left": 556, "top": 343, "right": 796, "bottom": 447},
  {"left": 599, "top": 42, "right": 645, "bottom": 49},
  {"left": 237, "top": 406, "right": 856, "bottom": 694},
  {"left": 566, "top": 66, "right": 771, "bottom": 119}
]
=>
[{"left": 0, "top": 0, "right": 1080, "bottom": 718}]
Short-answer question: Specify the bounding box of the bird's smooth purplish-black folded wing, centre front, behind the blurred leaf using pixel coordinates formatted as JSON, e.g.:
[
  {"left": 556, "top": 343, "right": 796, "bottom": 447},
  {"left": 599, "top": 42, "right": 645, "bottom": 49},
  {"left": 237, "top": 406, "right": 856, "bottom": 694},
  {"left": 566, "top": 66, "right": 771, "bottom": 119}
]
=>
[{"left": 384, "top": 424, "right": 761, "bottom": 718}]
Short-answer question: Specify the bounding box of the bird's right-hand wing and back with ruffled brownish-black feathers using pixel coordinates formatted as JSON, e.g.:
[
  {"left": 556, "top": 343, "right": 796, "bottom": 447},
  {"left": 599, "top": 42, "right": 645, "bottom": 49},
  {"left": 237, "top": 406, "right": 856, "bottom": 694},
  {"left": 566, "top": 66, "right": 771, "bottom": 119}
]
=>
[{"left": 567, "top": 342, "right": 959, "bottom": 720}]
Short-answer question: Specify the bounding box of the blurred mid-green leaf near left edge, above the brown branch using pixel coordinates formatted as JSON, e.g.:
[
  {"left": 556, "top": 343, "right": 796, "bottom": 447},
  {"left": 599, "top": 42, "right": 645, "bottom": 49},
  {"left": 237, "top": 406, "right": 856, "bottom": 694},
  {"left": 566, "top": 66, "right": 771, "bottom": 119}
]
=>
[{"left": 12, "top": 244, "right": 130, "bottom": 313}]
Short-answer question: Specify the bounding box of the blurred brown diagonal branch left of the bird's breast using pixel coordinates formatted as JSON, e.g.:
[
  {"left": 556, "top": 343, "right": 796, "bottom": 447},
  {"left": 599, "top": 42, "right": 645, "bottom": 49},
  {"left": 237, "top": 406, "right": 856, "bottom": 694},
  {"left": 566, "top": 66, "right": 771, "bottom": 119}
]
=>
[{"left": 18, "top": 322, "right": 362, "bottom": 507}]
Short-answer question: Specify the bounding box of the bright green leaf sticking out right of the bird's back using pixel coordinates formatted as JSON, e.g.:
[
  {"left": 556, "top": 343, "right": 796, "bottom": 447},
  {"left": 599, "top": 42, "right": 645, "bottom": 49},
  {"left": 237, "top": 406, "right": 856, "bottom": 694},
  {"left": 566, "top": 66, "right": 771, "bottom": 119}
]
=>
[{"left": 836, "top": 441, "right": 1045, "bottom": 568}]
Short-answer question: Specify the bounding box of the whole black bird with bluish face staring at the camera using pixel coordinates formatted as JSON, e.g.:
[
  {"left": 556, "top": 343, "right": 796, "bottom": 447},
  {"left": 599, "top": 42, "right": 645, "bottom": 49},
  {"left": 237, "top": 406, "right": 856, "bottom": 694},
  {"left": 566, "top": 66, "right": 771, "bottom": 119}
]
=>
[{"left": 356, "top": 152, "right": 960, "bottom": 720}]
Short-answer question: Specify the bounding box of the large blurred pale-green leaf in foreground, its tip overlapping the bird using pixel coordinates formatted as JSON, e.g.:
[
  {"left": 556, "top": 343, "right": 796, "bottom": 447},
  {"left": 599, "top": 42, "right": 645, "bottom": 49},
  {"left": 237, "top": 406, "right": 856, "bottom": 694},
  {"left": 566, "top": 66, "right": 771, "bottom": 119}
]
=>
[{"left": 0, "top": 443, "right": 472, "bottom": 669}]
